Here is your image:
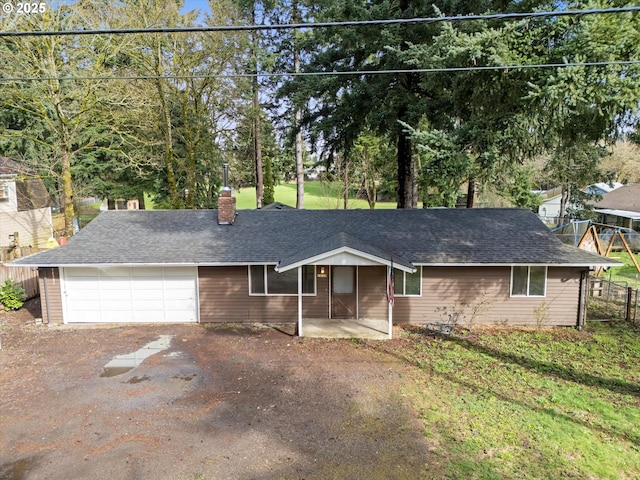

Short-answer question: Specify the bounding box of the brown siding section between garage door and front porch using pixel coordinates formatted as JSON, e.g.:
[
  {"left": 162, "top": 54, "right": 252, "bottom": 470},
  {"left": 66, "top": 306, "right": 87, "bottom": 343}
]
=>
[{"left": 198, "top": 266, "right": 298, "bottom": 323}]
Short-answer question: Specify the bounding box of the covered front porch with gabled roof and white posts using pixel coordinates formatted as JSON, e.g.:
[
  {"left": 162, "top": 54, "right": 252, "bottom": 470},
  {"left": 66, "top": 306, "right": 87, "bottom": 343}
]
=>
[{"left": 275, "top": 233, "right": 415, "bottom": 339}]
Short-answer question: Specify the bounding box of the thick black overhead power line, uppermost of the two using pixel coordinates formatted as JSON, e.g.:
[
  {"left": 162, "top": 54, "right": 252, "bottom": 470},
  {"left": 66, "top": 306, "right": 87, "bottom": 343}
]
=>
[{"left": 0, "top": 6, "right": 640, "bottom": 37}]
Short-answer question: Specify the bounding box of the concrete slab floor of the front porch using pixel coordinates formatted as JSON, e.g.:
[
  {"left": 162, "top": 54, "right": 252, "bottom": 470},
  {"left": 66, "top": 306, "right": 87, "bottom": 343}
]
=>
[{"left": 302, "top": 318, "right": 389, "bottom": 340}]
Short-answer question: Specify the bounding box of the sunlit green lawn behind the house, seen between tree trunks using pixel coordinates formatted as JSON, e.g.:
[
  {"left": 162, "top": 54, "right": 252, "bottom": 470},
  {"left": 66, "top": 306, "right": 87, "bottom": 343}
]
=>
[{"left": 235, "top": 182, "right": 396, "bottom": 210}]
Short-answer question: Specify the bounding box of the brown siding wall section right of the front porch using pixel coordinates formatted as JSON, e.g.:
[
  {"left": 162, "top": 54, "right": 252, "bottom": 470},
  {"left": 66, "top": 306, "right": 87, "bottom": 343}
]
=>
[{"left": 393, "top": 267, "right": 581, "bottom": 325}]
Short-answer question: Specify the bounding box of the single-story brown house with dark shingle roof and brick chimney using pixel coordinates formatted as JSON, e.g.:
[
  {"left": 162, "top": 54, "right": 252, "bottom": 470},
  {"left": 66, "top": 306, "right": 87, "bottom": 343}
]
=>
[{"left": 8, "top": 192, "right": 617, "bottom": 336}]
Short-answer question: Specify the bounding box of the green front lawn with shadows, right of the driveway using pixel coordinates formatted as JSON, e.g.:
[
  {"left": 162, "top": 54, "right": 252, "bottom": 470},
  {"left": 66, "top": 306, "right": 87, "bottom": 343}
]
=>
[{"left": 390, "top": 323, "right": 640, "bottom": 479}]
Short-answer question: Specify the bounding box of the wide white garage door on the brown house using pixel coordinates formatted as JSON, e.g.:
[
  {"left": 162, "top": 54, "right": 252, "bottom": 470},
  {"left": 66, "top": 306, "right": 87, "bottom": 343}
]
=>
[{"left": 61, "top": 267, "right": 198, "bottom": 323}]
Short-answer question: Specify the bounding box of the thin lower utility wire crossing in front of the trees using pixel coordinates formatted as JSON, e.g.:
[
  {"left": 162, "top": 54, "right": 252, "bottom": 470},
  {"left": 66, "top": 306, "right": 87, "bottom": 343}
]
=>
[{"left": 0, "top": 59, "right": 640, "bottom": 83}]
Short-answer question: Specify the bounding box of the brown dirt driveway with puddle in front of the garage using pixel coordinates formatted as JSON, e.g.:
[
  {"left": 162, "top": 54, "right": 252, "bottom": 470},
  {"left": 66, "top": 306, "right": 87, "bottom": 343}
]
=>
[{"left": 0, "top": 302, "right": 433, "bottom": 480}]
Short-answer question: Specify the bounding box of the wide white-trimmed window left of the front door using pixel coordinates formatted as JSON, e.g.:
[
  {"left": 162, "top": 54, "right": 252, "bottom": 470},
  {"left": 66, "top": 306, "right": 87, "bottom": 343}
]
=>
[{"left": 249, "top": 265, "right": 316, "bottom": 295}]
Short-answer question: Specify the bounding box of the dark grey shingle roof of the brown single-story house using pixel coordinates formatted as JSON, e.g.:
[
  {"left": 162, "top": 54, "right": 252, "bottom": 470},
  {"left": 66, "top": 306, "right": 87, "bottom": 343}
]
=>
[{"left": 14, "top": 209, "right": 615, "bottom": 270}]
